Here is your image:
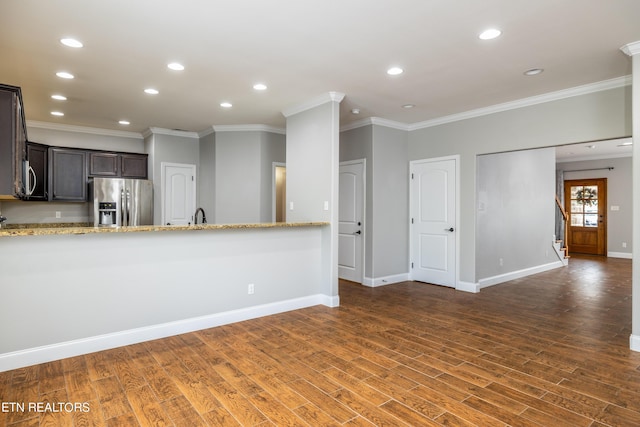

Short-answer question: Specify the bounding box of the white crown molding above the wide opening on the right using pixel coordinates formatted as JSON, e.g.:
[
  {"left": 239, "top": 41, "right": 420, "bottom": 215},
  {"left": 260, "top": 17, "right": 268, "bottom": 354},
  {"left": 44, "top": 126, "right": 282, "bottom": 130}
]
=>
[{"left": 409, "top": 76, "right": 631, "bottom": 131}]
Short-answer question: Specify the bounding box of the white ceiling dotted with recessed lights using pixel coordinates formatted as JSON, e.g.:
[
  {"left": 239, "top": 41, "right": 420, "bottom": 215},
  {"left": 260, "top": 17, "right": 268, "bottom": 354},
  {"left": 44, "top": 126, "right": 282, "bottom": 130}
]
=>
[{"left": 0, "top": 0, "right": 640, "bottom": 140}]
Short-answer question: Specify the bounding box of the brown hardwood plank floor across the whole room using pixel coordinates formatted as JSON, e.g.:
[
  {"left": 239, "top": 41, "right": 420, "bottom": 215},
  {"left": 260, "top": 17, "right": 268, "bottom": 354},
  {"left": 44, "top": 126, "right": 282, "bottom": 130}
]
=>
[{"left": 0, "top": 257, "right": 640, "bottom": 427}]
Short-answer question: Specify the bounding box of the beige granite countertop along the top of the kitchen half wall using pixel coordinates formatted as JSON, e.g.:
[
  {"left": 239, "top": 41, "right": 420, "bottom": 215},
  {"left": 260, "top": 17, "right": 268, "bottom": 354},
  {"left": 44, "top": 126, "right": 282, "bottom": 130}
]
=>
[{"left": 0, "top": 222, "right": 329, "bottom": 238}]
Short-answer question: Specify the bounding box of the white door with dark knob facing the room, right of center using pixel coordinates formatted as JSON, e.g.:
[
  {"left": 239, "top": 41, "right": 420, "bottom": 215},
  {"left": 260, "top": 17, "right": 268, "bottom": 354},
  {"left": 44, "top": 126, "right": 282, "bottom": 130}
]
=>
[{"left": 410, "top": 159, "right": 457, "bottom": 287}]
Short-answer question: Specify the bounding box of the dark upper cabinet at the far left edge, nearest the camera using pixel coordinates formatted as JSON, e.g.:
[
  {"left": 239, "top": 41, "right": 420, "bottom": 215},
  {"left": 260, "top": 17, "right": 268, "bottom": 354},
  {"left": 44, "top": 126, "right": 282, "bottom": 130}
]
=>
[{"left": 0, "top": 84, "right": 27, "bottom": 200}]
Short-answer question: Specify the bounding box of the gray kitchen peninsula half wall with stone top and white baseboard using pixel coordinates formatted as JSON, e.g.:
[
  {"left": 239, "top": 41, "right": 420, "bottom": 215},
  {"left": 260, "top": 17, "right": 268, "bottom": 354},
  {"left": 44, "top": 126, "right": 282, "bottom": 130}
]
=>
[{"left": 0, "top": 222, "right": 338, "bottom": 371}]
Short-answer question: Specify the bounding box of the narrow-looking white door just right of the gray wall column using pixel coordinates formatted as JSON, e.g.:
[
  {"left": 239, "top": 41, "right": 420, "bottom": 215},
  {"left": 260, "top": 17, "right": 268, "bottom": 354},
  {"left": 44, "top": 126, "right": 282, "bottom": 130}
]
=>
[{"left": 338, "top": 160, "right": 365, "bottom": 283}]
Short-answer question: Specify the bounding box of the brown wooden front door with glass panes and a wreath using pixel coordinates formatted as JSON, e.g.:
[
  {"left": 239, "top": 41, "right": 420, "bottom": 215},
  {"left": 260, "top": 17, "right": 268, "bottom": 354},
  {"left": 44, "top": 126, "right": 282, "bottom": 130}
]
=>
[{"left": 564, "top": 178, "right": 607, "bottom": 255}]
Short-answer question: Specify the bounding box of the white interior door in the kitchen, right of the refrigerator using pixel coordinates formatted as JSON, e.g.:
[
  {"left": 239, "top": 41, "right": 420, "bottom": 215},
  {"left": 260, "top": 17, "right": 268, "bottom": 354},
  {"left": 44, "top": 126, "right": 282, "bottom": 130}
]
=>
[{"left": 162, "top": 163, "right": 196, "bottom": 225}]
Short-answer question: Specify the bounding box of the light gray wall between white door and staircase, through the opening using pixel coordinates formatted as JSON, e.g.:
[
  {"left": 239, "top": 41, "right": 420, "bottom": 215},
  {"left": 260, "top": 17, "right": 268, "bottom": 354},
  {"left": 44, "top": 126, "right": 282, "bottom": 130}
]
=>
[{"left": 476, "top": 148, "right": 558, "bottom": 281}]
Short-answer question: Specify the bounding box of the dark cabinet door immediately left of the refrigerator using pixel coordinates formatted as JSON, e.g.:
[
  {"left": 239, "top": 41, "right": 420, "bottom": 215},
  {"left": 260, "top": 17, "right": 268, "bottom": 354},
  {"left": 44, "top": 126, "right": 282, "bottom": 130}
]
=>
[{"left": 49, "top": 148, "right": 87, "bottom": 202}]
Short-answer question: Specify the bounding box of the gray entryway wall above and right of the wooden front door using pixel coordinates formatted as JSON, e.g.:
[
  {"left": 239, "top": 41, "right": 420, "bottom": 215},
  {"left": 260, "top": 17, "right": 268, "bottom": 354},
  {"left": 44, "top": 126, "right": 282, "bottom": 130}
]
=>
[{"left": 556, "top": 157, "right": 633, "bottom": 257}]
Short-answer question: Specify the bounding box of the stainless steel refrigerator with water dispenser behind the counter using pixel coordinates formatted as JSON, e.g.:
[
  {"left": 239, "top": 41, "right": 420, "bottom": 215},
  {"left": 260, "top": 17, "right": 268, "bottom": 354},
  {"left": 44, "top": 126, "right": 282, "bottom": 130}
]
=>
[{"left": 89, "top": 178, "right": 153, "bottom": 227}]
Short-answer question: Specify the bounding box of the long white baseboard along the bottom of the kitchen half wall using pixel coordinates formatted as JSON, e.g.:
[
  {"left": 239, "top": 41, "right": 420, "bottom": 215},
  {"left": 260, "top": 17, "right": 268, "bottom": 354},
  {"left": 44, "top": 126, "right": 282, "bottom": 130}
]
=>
[{"left": 0, "top": 294, "right": 340, "bottom": 372}]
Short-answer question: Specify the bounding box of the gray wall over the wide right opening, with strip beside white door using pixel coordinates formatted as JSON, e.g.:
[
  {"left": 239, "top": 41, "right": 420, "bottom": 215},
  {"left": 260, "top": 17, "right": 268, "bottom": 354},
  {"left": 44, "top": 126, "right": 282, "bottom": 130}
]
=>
[{"left": 408, "top": 86, "right": 631, "bottom": 283}]
